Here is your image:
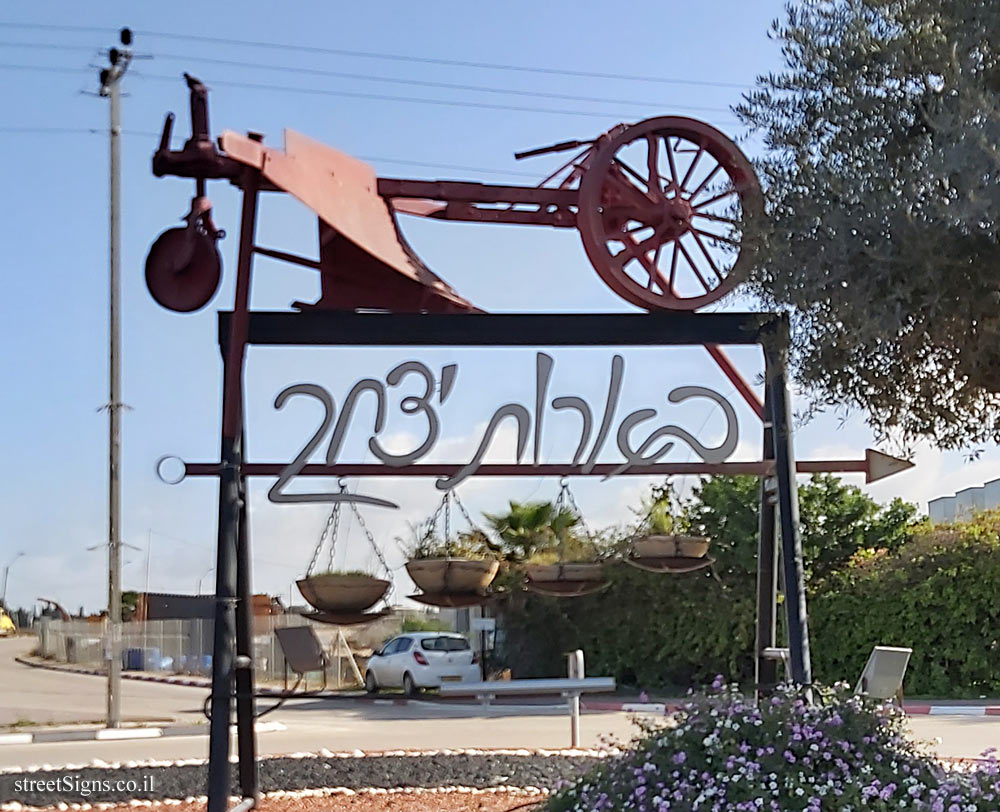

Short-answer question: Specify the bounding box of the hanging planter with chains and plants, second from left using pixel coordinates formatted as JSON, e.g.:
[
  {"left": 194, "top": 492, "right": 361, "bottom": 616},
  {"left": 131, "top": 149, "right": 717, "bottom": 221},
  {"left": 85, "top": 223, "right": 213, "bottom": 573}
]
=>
[{"left": 406, "top": 491, "right": 500, "bottom": 608}]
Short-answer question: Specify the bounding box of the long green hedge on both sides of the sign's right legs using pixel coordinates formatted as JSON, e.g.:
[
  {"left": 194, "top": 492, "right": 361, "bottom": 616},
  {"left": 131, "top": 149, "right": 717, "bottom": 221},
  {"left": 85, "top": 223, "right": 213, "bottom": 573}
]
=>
[{"left": 500, "top": 513, "right": 1000, "bottom": 697}]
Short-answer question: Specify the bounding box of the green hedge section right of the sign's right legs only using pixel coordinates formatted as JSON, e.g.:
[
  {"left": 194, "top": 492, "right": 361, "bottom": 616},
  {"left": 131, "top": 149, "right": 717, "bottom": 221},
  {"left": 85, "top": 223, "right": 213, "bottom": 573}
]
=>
[{"left": 810, "top": 513, "right": 1000, "bottom": 696}]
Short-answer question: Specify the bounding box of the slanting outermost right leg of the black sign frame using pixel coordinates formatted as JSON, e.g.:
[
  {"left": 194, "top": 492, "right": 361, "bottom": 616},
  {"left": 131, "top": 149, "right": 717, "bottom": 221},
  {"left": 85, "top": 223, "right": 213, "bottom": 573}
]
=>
[{"left": 764, "top": 334, "right": 812, "bottom": 686}]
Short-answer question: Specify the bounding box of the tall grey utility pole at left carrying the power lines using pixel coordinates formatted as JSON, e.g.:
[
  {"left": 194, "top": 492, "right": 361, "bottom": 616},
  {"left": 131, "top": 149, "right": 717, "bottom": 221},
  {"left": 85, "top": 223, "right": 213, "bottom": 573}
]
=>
[{"left": 100, "top": 28, "right": 132, "bottom": 727}]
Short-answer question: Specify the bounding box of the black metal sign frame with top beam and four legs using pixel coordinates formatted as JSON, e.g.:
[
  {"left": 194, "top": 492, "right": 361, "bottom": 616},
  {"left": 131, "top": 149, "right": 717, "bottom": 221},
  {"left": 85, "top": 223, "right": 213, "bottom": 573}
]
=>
[{"left": 201, "top": 167, "right": 812, "bottom": 812}]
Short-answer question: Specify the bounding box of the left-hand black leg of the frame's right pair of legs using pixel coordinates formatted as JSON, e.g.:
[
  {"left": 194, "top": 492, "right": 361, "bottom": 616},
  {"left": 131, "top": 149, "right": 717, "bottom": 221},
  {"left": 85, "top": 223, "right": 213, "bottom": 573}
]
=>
[{"left": 755, "top": 392, "right": 778, "bottom": 698}]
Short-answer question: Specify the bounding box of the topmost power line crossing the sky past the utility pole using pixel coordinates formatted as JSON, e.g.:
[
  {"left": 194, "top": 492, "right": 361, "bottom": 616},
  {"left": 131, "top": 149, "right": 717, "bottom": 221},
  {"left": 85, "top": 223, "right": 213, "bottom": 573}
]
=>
[{"left": 0, "top": 23, "right": 750, "bottom": 90}]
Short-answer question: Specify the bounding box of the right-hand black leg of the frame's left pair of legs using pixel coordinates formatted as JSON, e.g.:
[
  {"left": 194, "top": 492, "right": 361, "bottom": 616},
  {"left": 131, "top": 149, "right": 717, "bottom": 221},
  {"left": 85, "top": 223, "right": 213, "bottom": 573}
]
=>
[{"left": 236, "top": 454, "right": 259, "bottom": 802}]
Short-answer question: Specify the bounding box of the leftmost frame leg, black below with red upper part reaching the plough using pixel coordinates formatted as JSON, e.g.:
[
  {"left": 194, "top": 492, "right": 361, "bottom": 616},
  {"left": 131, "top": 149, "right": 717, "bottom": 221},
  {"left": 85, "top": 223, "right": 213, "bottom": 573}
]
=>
[{"left": 208, "top": 167, "right": 260, "bottom": 812}]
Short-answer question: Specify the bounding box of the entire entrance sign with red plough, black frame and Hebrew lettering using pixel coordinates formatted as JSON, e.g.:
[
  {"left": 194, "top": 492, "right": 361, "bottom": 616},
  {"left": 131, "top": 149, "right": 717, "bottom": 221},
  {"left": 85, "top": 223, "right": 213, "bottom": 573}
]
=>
[{"left": 145, "top": 74, "right": 906, "bottom": 812}]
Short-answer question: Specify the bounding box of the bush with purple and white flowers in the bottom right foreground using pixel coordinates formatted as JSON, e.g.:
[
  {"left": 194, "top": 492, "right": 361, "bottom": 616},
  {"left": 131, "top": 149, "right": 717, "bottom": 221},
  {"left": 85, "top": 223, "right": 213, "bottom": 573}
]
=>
[{"left": 547, "top": 678, "right": 1000, "bottom": 812}]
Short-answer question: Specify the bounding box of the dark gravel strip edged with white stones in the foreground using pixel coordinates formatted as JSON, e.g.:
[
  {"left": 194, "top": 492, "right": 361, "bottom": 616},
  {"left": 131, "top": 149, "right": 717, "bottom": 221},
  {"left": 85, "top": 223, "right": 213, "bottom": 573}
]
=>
[{"left": 0, "top": 751, "right": 600, "bottom": 809}]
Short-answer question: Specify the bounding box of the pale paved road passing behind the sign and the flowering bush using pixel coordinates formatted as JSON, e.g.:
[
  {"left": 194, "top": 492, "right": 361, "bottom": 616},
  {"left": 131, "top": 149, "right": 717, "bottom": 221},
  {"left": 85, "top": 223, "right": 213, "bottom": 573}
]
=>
[{"left": 0, "top": 640, "right": 1000, "bottom": 767}]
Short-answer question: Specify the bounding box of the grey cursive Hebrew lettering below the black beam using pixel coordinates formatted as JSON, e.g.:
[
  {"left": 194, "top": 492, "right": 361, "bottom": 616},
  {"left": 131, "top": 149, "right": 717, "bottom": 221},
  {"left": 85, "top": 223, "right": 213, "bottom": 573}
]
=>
[{"left": 268, "top": 352, "right": 739, "bottom": 507}]
